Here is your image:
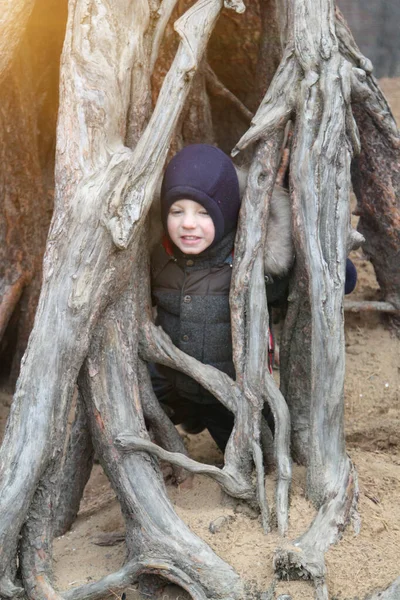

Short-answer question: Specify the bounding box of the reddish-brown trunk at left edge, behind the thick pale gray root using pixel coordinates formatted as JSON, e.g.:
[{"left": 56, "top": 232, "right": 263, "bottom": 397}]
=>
[{"left": 0, "top": 51, "right": 48, "bottom": 380}]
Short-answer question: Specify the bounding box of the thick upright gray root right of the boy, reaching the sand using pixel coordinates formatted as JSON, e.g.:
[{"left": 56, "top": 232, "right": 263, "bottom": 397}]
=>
[{"left": 233, "top": 0, "right": 359, "bottom": 598}]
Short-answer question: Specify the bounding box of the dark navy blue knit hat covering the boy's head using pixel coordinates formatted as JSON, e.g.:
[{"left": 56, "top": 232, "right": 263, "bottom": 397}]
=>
[{"left": 161, "top": 144, "right": 240, "bottom": 246}]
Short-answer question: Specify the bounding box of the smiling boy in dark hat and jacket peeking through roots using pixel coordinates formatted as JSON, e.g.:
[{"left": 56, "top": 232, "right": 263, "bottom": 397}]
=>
[{"left": 150, "top": 144, "right": 355, "bottom": 451}]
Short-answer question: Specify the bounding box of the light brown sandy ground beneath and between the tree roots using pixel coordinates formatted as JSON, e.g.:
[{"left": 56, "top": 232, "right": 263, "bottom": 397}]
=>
[{"left": 0, "top": 80, "right": 400, "bottom": 600}]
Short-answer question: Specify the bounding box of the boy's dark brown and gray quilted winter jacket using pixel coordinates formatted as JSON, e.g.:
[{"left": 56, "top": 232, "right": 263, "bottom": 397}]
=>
[{"left": 151, "top": 232, "right": 287, "bottom": 404}]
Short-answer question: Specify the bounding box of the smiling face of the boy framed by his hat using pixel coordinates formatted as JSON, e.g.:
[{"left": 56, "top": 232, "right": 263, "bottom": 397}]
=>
[{"left": 167, "top": 200, "right": 215, "bottom": 254}]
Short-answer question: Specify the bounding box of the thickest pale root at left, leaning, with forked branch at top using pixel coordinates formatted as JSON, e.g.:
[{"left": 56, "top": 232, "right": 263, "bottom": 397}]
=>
[{"left": 0, "top": 0, "right": 234, "bottom": 595}]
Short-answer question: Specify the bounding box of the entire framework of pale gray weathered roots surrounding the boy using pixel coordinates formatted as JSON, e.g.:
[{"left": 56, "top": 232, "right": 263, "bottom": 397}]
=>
[{"left": 0, "top": 0, "right": 400, "bottom": 600}]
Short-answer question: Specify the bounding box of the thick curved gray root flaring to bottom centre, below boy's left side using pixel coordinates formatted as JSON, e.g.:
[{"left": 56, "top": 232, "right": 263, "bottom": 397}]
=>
[{"left": 75, "top": 291, "right": 243, "bottom": 600}]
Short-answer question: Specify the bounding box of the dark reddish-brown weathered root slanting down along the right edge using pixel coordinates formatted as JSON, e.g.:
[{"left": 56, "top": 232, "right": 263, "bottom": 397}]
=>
[{"left": 337, "top": 13, "right": 400, "bottom": 308}]
